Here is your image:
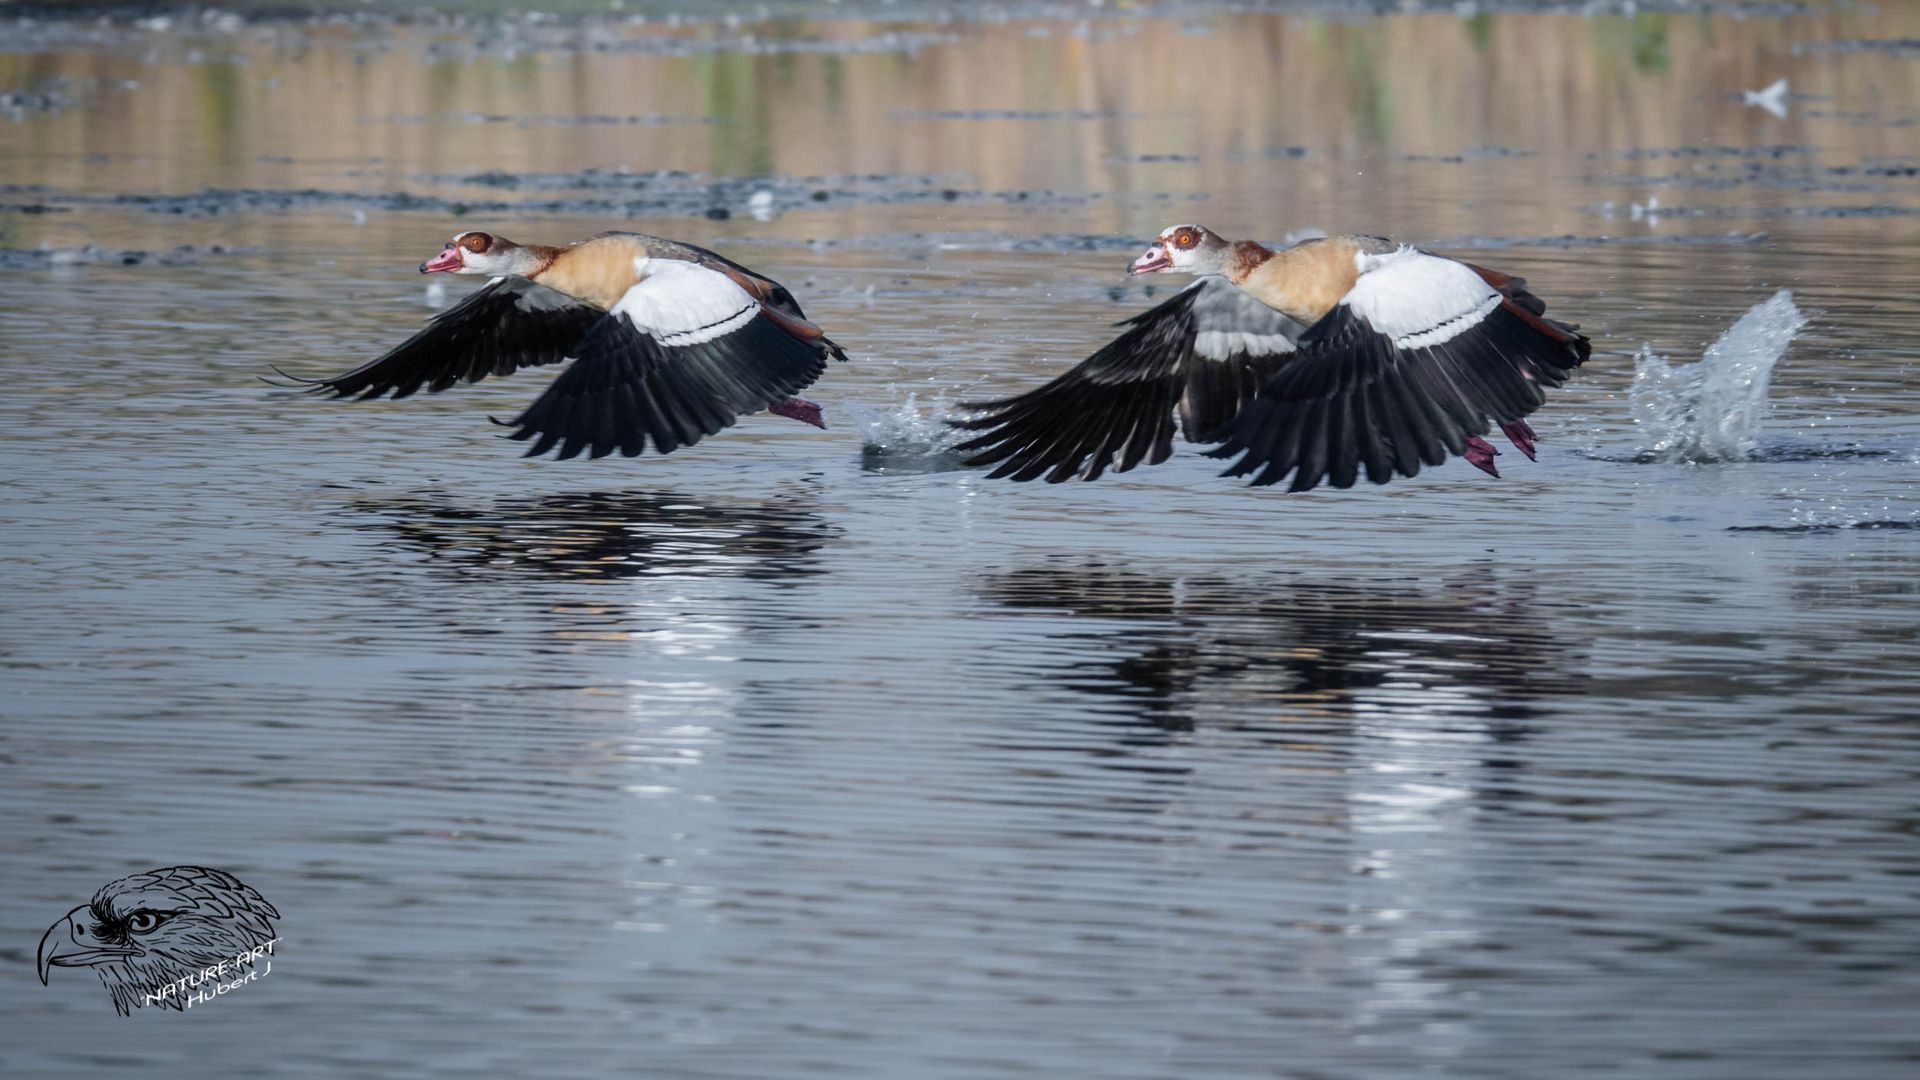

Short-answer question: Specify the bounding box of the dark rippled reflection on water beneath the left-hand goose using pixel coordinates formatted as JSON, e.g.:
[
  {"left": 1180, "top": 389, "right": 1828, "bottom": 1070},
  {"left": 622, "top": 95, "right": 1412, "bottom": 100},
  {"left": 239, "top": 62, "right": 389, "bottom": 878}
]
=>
[{"left": 339, "top": 492, "right": 841, "bottom": 582}]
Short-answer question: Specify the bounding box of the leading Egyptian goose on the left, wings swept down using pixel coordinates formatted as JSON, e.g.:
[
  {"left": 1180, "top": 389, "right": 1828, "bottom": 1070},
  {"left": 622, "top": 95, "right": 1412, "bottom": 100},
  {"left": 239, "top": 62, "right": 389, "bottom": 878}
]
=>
[{"left": 282, "top": 233, "right": 847, "bottom": 457}]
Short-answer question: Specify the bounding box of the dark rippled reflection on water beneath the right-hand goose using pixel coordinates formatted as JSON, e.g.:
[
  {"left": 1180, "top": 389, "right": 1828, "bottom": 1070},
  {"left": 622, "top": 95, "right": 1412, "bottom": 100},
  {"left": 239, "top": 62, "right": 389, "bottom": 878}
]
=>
[{"left": 979, "top": 567, "right": 1584, "bottom": 736}]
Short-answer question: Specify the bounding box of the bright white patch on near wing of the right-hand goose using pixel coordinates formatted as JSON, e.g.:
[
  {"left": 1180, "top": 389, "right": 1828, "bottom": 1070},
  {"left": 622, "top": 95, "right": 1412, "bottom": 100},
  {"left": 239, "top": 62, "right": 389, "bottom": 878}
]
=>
[{"left": 1340, "top": 246, "right": 1500, "bottom": 348}]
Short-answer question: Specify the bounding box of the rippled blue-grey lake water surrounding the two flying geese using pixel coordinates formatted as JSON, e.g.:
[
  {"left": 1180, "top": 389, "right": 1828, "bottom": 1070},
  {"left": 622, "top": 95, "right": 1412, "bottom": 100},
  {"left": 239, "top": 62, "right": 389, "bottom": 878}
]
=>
[{"left": 0, "top": 4, "right": 1920, "bottom": 1080}]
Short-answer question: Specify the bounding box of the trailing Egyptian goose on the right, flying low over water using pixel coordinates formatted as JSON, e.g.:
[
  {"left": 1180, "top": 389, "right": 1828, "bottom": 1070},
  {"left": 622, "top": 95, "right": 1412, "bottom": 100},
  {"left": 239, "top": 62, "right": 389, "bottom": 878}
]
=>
[{"left": 956, "top": 225, "right": 1590, "bottom": 492}]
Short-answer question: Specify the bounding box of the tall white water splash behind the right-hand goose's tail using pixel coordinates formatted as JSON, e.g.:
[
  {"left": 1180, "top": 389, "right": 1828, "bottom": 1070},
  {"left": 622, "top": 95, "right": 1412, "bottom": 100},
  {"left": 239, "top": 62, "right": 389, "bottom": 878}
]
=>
[{"left": 1628, "top": 288, "right": 1807, "bottom": 461}]
